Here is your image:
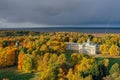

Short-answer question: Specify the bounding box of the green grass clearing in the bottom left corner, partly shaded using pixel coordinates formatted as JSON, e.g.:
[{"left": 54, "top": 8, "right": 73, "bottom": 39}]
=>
[{"left": 0, "top": 67, "right": 39, "bottom": 80}]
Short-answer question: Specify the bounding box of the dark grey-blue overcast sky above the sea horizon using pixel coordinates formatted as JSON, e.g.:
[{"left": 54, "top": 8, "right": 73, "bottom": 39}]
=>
[{"left": 0, "top": 0, "right": 120, "bottom": 28}]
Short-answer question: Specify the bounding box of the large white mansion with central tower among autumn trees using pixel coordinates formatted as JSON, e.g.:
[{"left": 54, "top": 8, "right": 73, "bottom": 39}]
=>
[{"left": 67, "top": 39, "right": 99, "bottom": 55}]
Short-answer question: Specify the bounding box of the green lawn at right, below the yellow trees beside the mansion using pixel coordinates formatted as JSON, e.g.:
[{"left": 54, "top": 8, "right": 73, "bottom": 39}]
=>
[{"left": 96, "top": 57, "right": 120, "bottom": 73}]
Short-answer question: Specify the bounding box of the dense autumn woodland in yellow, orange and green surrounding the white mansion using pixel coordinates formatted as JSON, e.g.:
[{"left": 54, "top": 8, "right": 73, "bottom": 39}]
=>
[{"left": 0, "top": 31, "right": 120, "bottom": 80}]
